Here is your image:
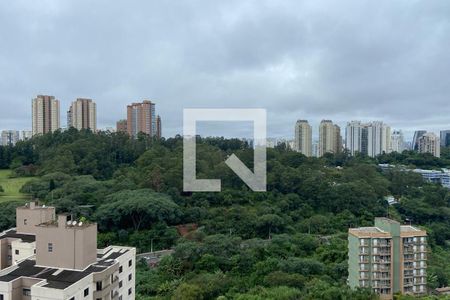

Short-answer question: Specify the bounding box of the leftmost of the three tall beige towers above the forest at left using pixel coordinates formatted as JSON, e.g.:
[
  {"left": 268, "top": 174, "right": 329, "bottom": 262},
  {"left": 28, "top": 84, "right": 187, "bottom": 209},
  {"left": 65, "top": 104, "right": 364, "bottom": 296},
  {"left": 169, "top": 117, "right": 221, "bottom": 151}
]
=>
[{"left": 32, "top": 95, "right": 60, "bottom": 135}]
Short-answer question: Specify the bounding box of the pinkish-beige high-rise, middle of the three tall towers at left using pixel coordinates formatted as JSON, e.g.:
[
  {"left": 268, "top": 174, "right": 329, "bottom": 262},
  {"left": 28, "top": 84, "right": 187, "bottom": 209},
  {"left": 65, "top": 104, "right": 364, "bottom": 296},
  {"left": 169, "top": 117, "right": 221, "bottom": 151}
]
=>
[{"left": 67, "top": 98, "right": 97, "bottom": 132}]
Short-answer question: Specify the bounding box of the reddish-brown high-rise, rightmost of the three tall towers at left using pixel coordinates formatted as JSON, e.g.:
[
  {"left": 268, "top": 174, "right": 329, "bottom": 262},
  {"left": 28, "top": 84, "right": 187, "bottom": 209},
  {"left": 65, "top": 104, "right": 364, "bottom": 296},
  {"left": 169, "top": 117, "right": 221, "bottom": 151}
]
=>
[{"left": 127, "top": 100, "right": 161, "bottom": 137}]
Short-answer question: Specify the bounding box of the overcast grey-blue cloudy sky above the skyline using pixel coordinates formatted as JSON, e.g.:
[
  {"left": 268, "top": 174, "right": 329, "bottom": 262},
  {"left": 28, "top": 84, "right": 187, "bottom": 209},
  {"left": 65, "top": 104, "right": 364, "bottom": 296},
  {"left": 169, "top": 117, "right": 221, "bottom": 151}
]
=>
[{"left": 0, "top": 0, "right": 450, "bottom": 138}]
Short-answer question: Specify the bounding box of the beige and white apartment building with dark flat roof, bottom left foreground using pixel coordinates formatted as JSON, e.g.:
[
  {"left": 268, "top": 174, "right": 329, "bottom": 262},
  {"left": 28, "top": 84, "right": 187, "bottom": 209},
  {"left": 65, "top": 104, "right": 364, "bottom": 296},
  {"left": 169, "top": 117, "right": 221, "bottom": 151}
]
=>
[{"left": 0, "top": 203, "right": 136, "bottom": 300}]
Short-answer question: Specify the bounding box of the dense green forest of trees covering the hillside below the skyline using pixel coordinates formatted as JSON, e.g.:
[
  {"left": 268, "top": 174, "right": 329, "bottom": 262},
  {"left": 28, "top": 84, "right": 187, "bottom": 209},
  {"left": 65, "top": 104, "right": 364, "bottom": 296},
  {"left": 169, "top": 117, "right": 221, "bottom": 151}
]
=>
[{"left": 0, "top": 129, "right": 450, "bottom": 300}]
